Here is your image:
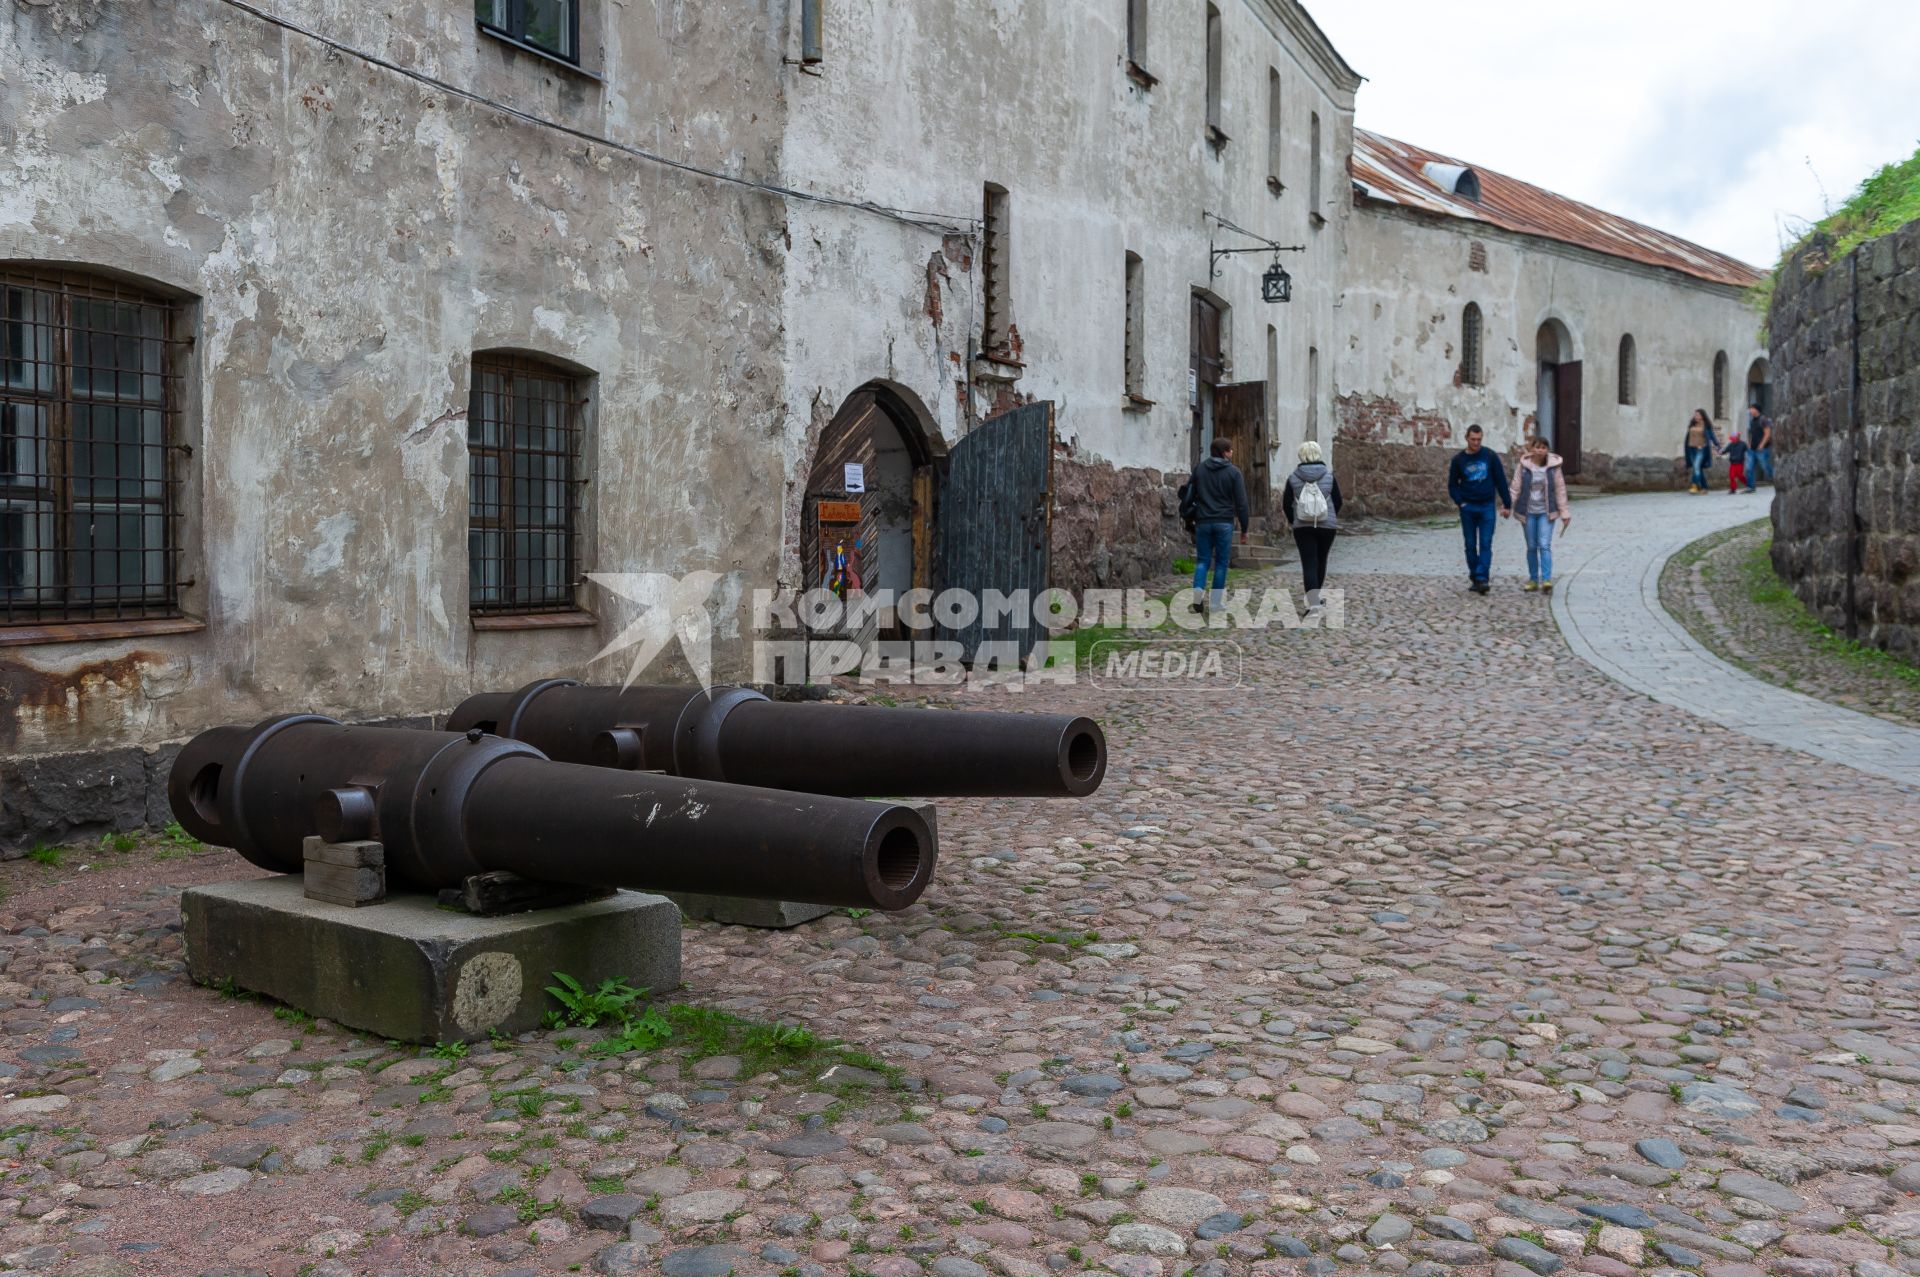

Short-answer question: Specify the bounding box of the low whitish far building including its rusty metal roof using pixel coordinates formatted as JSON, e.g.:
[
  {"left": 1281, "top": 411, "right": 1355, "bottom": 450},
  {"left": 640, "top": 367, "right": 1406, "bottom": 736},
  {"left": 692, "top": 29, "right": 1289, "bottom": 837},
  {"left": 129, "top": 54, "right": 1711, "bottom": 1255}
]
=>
[{"left": 1334, "top": 131, "right": 1768, "bottom": 515}]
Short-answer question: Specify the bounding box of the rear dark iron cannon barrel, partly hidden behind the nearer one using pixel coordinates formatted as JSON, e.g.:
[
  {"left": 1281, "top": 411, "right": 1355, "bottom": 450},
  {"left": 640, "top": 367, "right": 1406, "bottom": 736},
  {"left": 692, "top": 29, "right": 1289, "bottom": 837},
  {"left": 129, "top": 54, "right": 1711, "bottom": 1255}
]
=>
[{"left": 447, "top": 678, "right": 1106, "bottom": 799}]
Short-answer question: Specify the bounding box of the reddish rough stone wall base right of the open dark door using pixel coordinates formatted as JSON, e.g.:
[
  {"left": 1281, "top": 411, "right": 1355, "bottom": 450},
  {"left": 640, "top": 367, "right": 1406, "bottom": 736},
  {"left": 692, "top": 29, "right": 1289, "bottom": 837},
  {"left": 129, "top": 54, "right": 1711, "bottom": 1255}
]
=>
[{"left": 1052, "top": 451, "right": 1187, "bottom": 593}]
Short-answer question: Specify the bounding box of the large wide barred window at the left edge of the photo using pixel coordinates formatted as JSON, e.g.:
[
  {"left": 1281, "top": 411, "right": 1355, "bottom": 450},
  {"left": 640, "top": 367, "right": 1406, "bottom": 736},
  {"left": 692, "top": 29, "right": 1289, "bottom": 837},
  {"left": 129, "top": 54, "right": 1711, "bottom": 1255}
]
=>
[{"left": 0, "top": 263, "right": 184, "bottom": 626}]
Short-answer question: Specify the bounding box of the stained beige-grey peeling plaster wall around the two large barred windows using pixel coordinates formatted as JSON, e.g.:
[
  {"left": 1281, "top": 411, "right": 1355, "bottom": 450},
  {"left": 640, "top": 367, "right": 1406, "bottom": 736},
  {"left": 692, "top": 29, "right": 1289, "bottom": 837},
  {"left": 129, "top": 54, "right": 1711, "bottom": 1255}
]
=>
[{"left": 0, "top": 0, "right": 785, "bottom": 768}]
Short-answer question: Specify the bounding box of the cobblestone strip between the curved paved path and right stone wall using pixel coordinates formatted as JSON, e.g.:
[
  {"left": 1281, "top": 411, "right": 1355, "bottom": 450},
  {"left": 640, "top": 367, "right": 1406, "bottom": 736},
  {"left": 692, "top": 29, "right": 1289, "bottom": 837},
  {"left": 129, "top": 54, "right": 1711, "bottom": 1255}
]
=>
[{"left": 1661, "top": 520, "right": 1920, "bottom": 728}]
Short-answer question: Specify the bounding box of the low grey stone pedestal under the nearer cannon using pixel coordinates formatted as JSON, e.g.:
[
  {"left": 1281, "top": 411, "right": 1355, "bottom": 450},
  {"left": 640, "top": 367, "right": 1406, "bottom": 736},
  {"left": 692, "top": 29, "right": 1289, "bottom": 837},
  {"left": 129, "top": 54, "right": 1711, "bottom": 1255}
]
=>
[{"left": 180, "top": 876, "right": 680, "bottom": 1043}]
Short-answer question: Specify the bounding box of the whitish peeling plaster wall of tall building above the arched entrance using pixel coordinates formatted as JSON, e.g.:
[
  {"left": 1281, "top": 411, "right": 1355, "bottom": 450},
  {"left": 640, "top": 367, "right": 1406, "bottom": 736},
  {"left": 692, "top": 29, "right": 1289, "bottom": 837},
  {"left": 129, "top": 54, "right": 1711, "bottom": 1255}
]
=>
[{"left": 785, "top": 0, "right": 1356, "bottom": 584}]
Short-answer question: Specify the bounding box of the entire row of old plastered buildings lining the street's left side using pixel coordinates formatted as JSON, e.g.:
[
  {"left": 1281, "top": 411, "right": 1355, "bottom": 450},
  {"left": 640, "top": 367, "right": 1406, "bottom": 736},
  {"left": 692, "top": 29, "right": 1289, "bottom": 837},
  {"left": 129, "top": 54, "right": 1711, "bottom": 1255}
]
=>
[{"left": 0, "top": 0, "right": 1751, "bottom": 847}]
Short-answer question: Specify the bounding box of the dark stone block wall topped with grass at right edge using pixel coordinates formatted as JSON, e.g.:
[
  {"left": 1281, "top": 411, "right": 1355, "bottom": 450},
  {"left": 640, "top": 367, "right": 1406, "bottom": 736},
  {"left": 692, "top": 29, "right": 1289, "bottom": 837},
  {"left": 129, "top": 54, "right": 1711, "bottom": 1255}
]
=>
[{"left": 1768, "top": 221, "right": 1920, "bottom": 661}]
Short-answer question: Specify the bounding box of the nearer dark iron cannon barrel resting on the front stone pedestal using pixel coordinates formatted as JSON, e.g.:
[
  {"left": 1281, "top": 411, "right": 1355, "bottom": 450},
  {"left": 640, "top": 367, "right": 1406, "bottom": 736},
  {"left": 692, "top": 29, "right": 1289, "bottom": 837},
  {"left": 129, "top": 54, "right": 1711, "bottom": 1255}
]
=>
[{"left": 167, "top": 714, "right": 935, "bottom": 910}]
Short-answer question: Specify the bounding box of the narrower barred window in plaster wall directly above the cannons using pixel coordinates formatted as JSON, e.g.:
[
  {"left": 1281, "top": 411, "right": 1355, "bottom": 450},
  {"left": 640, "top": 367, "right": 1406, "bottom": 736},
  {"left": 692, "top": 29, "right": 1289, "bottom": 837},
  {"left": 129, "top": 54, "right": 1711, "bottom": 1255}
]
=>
[{"left": 467, "top": 355, "right": 586, "bottom": 616}]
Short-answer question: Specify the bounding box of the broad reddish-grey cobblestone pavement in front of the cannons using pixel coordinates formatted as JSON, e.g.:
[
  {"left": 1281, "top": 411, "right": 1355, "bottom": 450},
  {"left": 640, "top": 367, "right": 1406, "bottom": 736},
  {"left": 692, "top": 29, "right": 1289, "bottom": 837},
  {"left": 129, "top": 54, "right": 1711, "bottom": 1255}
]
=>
[{"left": 0, "top": 522, "right": 1920, "bottom": 1277}]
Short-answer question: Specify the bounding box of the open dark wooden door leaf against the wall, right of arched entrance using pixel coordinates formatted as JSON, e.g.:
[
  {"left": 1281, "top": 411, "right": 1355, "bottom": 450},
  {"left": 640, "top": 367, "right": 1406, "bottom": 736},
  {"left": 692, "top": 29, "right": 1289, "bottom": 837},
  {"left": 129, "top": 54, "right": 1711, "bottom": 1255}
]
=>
[{"left": 935, "top": 403, "right": 1054, "bottom": 661}]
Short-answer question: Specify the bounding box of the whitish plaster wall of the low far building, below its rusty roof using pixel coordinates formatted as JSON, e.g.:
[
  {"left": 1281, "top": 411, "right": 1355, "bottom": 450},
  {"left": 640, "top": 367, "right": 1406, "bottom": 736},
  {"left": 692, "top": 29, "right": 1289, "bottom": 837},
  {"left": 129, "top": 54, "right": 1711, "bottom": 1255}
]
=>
[{"left": 1334, "top": 204, "right": 1766, "bottom": 513}]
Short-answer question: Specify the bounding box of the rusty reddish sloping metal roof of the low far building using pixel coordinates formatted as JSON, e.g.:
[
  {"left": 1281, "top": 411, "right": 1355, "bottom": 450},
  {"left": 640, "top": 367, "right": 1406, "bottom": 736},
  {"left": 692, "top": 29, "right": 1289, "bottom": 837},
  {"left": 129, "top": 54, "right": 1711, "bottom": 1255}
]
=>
[{"left": 1354, "top": 129, "right": 1764, "bottom": 288}]
